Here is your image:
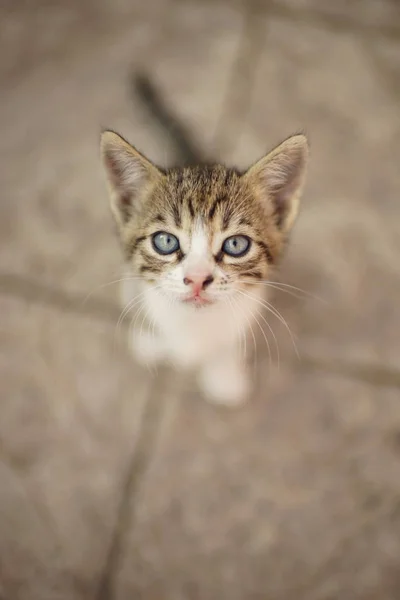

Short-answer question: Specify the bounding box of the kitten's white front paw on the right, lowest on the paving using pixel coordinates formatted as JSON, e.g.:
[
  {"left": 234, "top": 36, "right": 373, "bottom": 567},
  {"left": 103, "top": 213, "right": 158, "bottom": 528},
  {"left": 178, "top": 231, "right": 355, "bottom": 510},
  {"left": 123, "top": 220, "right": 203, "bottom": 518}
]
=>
[{"left": 198, "top": 362, "right": 251, "bottom": 407}]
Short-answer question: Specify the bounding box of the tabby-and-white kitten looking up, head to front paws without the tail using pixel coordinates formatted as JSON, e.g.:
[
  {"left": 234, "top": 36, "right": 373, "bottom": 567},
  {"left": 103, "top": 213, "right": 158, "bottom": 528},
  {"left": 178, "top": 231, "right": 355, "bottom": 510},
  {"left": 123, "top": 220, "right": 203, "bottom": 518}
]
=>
[{"left": 101, "top": 131, "right": 308, "bottom": 405}]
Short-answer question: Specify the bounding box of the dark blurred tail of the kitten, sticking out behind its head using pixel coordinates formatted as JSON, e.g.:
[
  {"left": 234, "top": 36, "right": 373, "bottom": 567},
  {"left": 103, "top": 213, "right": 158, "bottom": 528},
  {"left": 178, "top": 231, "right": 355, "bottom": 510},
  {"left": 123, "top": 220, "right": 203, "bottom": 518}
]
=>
[{"left": 131, "top": 73, "right": 203, "bottom": 164}]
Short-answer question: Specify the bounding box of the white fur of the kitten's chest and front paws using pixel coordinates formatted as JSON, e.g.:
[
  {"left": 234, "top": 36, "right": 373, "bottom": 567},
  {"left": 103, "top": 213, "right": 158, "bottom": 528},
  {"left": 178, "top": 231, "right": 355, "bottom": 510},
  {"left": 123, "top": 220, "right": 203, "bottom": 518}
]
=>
[{"left": 121, "top": 280, "right": 262, "bottom": 404}]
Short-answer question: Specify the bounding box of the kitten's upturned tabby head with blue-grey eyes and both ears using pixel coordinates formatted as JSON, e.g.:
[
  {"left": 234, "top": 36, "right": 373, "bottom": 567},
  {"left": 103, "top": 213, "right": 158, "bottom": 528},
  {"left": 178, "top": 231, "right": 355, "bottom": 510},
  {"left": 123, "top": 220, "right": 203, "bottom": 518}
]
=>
[{"left": 101, "top": 131, "right": 308, "bottom": 307}]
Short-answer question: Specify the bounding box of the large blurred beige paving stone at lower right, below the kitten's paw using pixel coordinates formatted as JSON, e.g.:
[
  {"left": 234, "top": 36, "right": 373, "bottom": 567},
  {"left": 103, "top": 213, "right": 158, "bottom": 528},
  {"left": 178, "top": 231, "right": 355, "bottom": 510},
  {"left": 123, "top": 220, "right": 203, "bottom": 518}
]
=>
[{"left": 117, "top": 370, "right": 400, "bottom": 600}]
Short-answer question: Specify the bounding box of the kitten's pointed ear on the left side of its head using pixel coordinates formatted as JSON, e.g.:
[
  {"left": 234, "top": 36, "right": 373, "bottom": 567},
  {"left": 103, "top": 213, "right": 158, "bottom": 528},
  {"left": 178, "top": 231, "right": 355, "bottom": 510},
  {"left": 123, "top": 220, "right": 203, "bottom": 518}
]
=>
[{"left": 101, "top": 131, "right": 162, "bottom": 225}]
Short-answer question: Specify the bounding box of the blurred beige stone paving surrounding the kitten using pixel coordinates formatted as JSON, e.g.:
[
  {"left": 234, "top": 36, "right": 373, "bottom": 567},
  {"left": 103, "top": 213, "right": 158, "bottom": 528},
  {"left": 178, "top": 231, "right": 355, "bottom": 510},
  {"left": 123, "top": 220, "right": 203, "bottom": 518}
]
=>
[{"left": 0, "top": 0, "right": 400, "bottom": 600}]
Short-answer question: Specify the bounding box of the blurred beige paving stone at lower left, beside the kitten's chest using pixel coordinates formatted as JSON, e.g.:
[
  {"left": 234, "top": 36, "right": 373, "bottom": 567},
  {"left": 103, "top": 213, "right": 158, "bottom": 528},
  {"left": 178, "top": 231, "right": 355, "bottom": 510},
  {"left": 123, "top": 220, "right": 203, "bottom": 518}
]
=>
[{"left": 0, "top": 299, "right": 152, "bottom": 600}]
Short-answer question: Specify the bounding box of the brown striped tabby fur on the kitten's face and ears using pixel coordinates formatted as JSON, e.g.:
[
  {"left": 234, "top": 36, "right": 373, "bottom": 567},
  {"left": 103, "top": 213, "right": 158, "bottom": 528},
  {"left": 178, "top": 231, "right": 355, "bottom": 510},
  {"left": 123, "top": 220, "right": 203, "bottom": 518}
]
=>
[{"left": 102, "top": 131, "right": 308, "bottom": 282}]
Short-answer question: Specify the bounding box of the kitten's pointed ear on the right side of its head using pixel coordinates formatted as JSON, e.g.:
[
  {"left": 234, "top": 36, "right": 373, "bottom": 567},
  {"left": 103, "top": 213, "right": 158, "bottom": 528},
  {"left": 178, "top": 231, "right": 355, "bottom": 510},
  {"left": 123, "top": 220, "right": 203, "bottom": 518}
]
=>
[{"left": 245, "top": 134, "right": 309, "bottom": 233}]
